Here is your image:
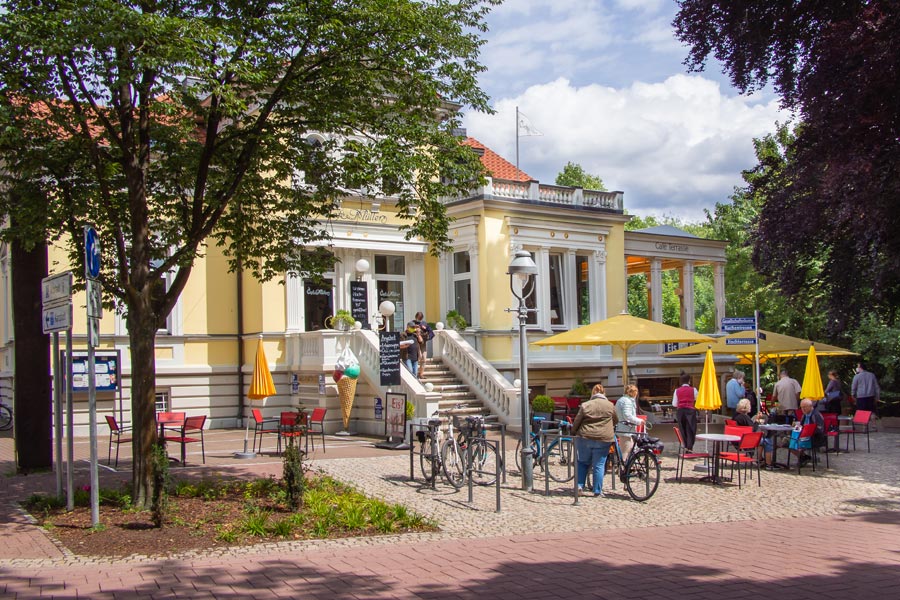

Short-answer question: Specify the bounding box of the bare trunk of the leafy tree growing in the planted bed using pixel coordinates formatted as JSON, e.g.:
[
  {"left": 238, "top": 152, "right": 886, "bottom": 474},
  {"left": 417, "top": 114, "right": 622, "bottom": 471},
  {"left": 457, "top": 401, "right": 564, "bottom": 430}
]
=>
[{"left": 127, "top": 302, "right": 157, "bottom": 508}]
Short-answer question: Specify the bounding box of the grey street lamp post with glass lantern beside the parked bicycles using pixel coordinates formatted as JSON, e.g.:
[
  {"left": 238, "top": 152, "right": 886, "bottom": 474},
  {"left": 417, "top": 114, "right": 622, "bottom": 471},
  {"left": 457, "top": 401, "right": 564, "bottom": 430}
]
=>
[{"left": 506, "top": 250, "right": 537, "bottom": 491}]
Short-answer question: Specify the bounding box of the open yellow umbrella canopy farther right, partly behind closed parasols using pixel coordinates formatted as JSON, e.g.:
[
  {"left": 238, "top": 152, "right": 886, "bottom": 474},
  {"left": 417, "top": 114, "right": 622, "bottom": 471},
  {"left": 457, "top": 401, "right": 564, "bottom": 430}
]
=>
[{"left": 666, "top": 329, "right": 855, "bottom": 366}]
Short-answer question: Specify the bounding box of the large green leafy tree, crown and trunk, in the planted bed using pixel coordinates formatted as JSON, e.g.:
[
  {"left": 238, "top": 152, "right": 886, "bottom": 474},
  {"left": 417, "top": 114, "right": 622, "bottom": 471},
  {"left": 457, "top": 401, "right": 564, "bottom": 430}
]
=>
[{"left": 0, "top": 0, "right": 495, "bottom": 505}]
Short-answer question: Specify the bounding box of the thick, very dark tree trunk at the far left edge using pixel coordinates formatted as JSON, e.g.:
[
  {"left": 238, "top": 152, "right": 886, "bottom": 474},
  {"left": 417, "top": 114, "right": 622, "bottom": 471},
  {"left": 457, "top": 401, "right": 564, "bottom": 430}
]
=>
[{"left": 11, "top": 241, "right": 53, "bottom": 472}]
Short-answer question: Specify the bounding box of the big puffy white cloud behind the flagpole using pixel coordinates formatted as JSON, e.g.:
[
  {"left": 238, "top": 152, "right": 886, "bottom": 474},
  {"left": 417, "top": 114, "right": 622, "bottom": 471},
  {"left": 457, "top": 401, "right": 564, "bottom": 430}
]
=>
[{"left": 465, "top": 74, "right": 788, "bottom": 220}]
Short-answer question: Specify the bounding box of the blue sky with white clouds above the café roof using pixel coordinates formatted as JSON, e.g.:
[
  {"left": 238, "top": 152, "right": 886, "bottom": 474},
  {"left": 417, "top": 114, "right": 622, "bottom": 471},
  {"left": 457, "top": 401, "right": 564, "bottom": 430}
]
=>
[{"left": 464, "top": 0, "right": 789, "bottom": 222}]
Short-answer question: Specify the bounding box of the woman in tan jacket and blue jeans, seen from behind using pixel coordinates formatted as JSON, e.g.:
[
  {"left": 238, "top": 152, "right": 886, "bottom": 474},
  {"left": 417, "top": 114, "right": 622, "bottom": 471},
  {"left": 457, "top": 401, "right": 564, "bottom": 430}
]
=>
[{"left": 572, "top": 383, "right": 616, "bottom": 497}]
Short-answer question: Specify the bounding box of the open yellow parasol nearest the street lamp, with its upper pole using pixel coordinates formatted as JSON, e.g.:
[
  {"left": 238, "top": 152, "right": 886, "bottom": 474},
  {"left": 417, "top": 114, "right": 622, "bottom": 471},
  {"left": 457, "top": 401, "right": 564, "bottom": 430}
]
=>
[{"left": 534, "top": 312, "right": 712, "bottom": 382}]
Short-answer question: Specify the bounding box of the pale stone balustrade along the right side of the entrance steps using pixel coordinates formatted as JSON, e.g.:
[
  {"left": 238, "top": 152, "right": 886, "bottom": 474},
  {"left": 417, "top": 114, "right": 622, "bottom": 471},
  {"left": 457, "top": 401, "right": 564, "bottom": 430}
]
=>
[{"left": 433, "top": 329, "right": 521, "bottom": 425}]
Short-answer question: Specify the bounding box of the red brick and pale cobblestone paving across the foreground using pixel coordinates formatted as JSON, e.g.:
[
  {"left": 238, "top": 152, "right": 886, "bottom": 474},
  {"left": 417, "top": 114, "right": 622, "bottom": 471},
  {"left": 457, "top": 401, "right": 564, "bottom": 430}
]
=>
[{"left": 0, "top": 432, "right": 900, "bottom": 599}]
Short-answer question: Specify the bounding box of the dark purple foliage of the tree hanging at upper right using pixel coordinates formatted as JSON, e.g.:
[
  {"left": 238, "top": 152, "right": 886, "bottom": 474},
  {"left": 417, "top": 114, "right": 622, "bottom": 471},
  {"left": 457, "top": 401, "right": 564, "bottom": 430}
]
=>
[{"left": 675, "top": 0, "right": 900, "bottom": 334}]
